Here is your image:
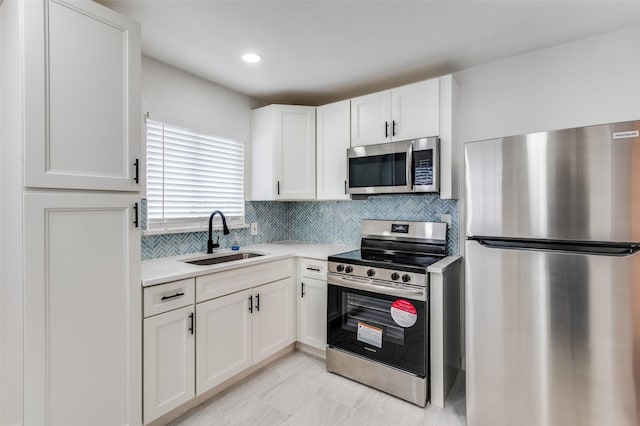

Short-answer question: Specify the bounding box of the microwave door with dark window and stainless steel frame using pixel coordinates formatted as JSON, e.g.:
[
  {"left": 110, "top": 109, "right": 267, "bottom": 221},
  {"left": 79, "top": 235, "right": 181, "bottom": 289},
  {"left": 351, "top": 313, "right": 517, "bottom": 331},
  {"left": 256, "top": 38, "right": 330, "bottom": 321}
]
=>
[{"left": 347, "top": 141, "right": 413, "bottom": 194}]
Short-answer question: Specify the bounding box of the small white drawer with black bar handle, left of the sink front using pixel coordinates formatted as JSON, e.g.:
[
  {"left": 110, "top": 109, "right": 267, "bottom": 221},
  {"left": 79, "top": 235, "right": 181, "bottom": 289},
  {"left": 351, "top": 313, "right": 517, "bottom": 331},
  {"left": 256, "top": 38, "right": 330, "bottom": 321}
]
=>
[{"left": 144, "top": 278, "right": 195, "bottom": 318}]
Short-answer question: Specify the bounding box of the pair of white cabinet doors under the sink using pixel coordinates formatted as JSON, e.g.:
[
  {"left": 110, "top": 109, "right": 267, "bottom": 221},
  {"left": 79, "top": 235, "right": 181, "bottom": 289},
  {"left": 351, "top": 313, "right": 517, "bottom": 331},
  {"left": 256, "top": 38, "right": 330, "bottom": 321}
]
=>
[{"left": 196, "top": 278, "right": 295, "bottom": 395}]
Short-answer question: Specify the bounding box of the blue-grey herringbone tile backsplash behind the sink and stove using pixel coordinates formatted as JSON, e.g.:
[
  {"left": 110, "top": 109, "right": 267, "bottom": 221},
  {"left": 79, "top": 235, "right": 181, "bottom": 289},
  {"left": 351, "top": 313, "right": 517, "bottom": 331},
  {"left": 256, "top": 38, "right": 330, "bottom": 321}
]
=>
[{"left": 142, "top": 195, "right": 459, "bottom": 259}]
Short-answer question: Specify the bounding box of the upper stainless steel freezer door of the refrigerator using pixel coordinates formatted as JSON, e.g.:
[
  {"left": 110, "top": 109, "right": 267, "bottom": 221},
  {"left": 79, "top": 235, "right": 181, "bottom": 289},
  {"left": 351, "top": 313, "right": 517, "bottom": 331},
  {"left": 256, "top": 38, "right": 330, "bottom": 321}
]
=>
[{"left": 465, "top": 121, "right": 640, "bottom": 242}]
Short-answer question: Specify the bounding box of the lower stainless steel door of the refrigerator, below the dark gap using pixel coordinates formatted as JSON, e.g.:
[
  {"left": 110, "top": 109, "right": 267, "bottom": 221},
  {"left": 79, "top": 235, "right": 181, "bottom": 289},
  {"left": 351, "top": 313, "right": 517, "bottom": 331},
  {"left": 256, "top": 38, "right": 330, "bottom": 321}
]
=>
[{"left": 465, "top": 241, "right": 640, "bottom": 426}]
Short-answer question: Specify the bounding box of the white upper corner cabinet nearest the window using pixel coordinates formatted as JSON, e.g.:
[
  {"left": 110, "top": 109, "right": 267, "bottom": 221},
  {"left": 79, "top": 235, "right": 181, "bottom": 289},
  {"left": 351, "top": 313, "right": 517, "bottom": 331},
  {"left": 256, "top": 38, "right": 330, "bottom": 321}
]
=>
[{"left": 248, "top": 105, "right": 316, "bottom": 201}]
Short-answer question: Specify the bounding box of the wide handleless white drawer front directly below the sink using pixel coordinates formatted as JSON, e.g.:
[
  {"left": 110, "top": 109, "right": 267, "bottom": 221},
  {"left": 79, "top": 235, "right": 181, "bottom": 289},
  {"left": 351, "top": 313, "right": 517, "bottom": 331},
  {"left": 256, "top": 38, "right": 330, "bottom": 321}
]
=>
[{"left": 196, "top": 259, "right": 293, "bottom": 302}]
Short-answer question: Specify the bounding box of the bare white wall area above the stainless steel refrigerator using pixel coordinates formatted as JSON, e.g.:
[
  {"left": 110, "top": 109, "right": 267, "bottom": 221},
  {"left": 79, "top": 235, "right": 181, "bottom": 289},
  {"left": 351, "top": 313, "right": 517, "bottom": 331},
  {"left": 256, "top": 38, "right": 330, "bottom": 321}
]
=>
[{"left": 455, "top": 25, "right": 640, "bottom": 143}]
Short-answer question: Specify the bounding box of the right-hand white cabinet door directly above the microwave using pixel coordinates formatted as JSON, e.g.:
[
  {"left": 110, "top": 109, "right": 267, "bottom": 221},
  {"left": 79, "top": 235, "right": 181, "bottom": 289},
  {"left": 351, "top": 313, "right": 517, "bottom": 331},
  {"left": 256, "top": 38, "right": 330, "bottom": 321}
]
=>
[{"left": 391, "top": 78, "right": 440, "bottom": 141}]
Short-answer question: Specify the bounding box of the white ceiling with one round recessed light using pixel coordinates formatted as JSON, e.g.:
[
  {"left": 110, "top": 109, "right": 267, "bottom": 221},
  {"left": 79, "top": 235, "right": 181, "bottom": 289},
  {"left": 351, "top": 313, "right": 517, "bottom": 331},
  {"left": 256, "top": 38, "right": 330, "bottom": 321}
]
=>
[{"left": 98, "top": 0, "right": 640, "bottom": 105}]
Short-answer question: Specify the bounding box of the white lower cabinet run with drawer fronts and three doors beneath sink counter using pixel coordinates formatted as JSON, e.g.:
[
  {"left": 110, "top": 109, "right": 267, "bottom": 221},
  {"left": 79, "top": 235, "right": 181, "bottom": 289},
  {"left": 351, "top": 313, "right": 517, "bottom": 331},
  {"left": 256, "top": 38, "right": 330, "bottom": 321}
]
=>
[{"left": 143, "top": 259, "right": 296, "bottom": 424}]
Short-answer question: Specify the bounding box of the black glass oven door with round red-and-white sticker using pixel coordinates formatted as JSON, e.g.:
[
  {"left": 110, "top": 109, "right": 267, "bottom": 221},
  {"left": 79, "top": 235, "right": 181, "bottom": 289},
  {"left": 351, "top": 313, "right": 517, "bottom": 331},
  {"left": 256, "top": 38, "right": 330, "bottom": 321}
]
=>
[{"left": 327, "top": 274, "right": 429, "bottom": 377}]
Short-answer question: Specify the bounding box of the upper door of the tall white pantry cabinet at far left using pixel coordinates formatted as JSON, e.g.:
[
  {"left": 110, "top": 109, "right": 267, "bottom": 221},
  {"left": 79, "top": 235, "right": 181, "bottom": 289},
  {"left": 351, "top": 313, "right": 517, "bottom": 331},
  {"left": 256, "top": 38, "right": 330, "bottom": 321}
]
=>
[{"left": 24, "top": 0, "right": 142, "bottom": 191}]
